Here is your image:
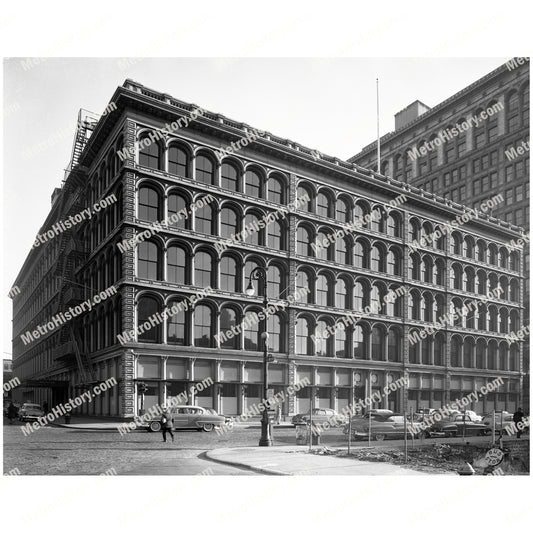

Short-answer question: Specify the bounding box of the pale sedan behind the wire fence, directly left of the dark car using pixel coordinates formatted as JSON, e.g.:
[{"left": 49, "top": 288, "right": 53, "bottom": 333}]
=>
[{"left": 343, "top": 413, "right": 423, "bottom": 440}]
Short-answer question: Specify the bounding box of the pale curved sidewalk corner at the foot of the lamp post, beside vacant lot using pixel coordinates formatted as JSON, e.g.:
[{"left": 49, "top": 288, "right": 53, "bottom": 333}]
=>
[{"left": 206, "top": 446, "right": 438, "bottom": 476}]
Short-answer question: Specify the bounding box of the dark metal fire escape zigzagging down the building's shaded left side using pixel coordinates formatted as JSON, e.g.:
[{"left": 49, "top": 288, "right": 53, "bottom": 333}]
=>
[{"left": 53, "top": 110, "right": 102, "bottom": 389}]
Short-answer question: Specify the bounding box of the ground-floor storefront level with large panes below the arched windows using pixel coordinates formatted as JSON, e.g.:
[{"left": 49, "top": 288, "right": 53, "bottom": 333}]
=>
[{"left": 13, "top": 350, "right": 521, "bottom": 418}]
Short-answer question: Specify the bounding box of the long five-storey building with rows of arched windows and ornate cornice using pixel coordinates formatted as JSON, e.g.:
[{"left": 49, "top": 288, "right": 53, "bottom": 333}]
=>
[{"left": 13, "top": 80, "right": 524, "bottom": 417}]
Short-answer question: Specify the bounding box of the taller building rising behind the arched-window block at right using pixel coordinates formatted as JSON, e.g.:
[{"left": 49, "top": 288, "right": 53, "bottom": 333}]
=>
[{"left": 349, "top": 58, "right": 529, "bottom": 402}]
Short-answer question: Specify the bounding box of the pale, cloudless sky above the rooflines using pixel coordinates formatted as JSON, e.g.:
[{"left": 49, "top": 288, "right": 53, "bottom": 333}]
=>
[{"left": 2, "top": 57, "right": 509, "bottom": 358}]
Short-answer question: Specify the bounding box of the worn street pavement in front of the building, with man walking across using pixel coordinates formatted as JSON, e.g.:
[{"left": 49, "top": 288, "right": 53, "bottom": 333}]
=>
[{"left": 4, "top": 422, "right": 508, "bottom": 475}]
